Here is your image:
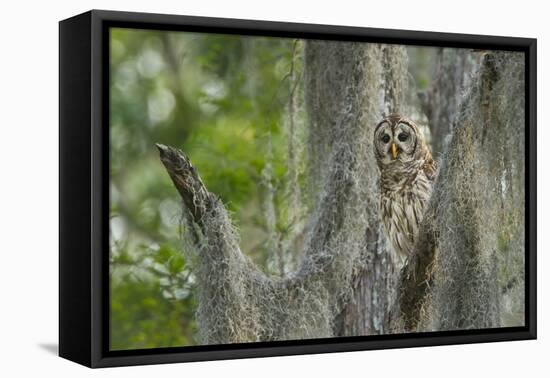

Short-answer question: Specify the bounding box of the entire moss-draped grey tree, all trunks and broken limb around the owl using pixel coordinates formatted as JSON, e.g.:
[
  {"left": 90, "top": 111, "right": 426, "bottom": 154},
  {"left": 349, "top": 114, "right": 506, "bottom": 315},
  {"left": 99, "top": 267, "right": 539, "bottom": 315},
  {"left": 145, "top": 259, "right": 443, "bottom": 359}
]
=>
[{"left": 158, "top": 45, "right": 524, "bottom": 344}]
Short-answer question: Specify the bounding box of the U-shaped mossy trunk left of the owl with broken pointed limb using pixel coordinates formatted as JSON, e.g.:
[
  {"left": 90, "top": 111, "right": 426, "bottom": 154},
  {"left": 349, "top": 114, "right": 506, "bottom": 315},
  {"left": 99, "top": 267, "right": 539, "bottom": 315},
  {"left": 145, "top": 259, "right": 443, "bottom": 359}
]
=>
[{"left": 159, "top": 41, "right": 390, "bottom": 344}]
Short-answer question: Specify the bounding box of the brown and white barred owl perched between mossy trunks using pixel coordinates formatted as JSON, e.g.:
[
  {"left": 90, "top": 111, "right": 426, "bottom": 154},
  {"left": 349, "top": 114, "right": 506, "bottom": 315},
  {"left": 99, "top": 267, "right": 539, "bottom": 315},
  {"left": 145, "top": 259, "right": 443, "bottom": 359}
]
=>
[{"left": 373, "top": 114, "right": 437, "bottom": 261}]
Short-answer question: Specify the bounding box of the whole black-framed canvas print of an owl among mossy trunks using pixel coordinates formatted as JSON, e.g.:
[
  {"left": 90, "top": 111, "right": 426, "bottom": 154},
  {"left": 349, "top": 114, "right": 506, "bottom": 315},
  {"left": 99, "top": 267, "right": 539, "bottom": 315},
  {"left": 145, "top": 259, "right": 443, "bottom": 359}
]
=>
[{"left": 59, "top": 10, "right": 536, "bottom": 367}]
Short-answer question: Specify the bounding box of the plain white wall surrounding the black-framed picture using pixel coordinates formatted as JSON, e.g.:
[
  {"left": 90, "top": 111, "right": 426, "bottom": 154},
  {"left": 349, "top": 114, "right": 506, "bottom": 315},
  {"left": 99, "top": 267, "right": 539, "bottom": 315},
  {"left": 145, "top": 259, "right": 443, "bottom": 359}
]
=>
[{"left": 0, "top": 0, "right": 550, "bottom": 378}]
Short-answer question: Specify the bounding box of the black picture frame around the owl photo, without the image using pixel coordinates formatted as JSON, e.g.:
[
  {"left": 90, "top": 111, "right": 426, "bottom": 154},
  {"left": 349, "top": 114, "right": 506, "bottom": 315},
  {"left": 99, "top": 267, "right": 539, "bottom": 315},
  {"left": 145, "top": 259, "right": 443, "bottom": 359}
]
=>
[{"left": 59, "top": 10, "right": 537, "bottom": 368}]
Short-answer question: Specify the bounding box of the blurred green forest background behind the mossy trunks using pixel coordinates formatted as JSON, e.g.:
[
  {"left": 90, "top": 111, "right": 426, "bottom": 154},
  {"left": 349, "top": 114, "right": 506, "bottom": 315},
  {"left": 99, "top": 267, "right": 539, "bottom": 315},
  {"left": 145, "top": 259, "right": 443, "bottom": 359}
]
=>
[{"left": 110, "top": 28, "right": 437, "bottom": 350}]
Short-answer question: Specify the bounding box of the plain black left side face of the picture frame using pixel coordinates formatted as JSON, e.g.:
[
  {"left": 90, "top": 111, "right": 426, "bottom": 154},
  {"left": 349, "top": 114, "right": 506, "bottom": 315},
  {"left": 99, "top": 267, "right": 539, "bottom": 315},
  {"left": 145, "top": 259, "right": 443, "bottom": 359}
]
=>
[{"left": 59, "top": 12, "right": 93, "bottom": 366}]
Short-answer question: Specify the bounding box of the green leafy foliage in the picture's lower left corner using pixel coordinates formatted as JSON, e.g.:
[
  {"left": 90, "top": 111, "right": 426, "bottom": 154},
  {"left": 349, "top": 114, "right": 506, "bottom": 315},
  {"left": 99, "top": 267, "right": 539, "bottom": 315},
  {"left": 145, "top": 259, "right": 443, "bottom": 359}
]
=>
[{"left": 110, "top": 245, "right": 196, "bottom": 350}]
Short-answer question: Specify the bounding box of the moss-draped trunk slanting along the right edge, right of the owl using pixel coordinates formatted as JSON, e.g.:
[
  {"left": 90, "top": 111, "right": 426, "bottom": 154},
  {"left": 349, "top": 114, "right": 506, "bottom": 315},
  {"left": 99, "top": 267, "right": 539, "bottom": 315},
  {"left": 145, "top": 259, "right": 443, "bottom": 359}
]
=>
[{"left": 394, "top": 52, "right": 525, "bottom": 331}]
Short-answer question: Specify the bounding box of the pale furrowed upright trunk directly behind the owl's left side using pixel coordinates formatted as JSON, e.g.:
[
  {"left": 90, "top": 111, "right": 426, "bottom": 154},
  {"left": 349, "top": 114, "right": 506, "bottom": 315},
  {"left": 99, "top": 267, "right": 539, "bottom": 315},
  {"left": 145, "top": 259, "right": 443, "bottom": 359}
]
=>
[{"left": 334, "top": 45, "right": 408, "bottom": 336}]
